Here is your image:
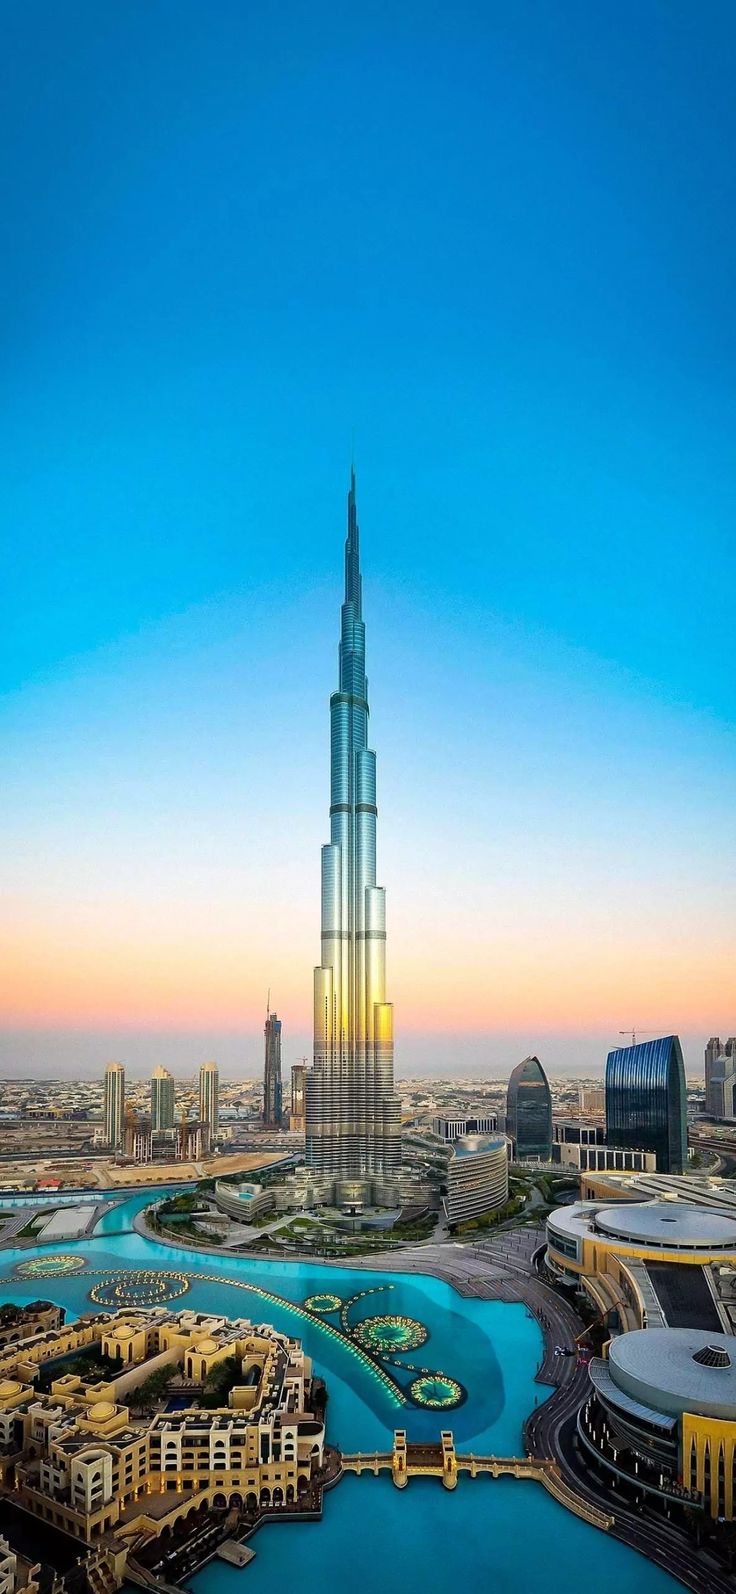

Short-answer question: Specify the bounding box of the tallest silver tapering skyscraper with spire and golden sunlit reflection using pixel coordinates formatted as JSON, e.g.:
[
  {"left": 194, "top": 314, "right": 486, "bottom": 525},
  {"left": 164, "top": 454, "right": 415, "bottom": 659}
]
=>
[{"left": 306, "top": 470, "right": 401, "bottom": 1178}]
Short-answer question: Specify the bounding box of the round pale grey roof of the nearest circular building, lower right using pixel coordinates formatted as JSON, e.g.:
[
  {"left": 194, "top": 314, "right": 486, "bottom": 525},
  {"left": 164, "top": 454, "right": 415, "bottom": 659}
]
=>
[{"left": 609, "top": 1328, "right": 736, "bottom": 1422}]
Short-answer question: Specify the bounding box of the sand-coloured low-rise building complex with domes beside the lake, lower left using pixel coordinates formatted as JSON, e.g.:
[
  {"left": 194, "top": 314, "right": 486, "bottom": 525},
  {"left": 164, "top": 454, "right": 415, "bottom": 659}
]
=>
[{"left": 0, "top": 1309, "right": 325, "bottom": 1555}]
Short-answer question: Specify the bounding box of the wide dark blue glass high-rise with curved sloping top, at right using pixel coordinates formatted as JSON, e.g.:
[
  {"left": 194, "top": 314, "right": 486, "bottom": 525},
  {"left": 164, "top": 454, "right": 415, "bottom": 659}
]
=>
[{"left": 605, "top": 1035, "right": 687, "bottom": 1173}]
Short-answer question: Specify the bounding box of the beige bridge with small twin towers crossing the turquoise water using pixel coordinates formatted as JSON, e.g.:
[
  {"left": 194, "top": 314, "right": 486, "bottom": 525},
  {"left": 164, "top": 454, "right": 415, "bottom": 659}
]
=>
[{"left": 343, "top": 1428, "right": 613, "bottom": 1532}]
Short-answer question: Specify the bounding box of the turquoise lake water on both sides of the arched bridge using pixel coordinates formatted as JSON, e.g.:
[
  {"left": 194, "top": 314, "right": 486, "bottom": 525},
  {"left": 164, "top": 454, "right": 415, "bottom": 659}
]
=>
[{"left": 0, "top": 1191, "right": 680, "bottom": 1594}]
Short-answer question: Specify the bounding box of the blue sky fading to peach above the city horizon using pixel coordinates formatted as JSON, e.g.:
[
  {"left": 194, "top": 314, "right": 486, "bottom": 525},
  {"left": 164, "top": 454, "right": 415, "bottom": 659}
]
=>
[{"left": 0, "top": 0, "right": 736, "bottom": 1073}]
